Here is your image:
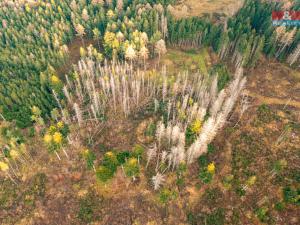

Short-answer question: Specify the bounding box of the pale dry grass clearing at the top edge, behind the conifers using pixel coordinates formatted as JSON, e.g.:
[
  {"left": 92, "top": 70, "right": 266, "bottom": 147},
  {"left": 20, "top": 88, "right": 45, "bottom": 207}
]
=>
[{"left": 172, "top": 0, "right": 244, "bottom": 18}]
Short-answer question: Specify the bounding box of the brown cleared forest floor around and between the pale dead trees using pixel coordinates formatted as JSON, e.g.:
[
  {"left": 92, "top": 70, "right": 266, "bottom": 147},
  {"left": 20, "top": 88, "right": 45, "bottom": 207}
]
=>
[{"left": 0, "top": 49, "right": 300, "bottom": 225}]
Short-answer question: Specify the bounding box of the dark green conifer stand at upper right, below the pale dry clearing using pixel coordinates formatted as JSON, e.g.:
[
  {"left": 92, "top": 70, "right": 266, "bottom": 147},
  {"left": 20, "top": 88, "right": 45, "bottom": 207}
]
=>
[{"left": 168, "top": 1, "right": 300, "bottom": 67}]
